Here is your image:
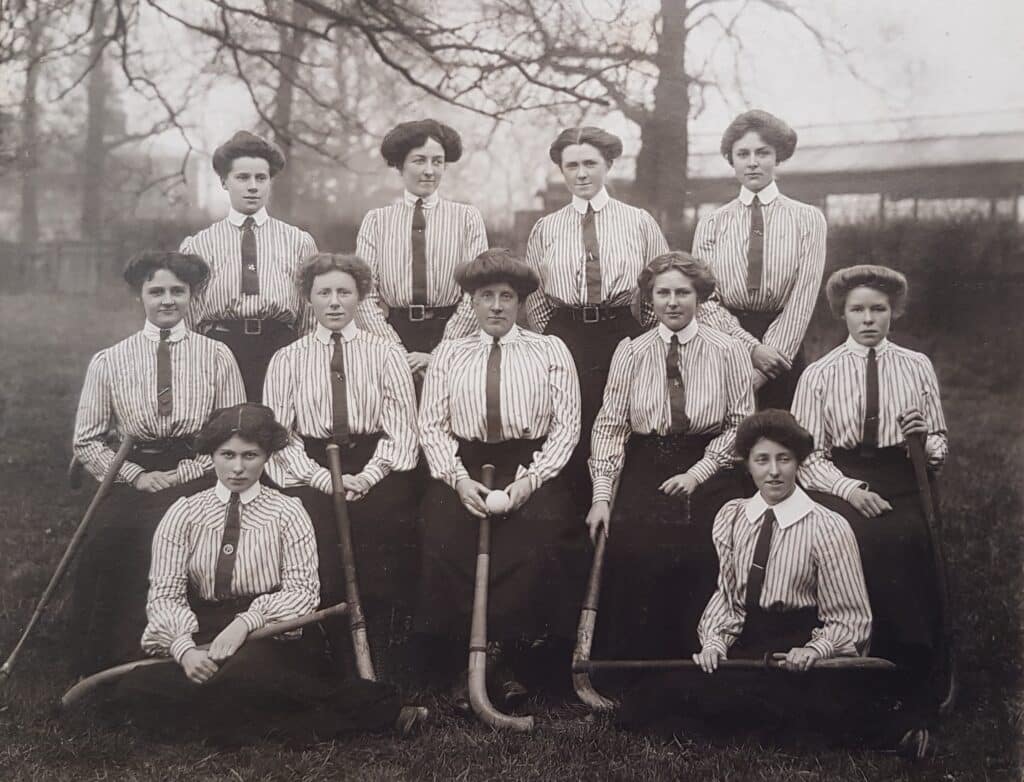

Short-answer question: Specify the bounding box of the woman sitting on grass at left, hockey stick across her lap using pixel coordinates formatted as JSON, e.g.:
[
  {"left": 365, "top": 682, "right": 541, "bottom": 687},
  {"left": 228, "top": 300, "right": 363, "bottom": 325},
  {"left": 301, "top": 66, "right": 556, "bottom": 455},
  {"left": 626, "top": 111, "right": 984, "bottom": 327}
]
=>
[{"left": 114, "top": 403, "right": 427, "bottom": 742}]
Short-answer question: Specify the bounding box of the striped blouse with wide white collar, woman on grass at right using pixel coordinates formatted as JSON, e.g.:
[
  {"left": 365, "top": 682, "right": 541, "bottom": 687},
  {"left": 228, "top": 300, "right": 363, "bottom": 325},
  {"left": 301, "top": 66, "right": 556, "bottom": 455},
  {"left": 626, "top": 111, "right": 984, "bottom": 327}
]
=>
[{"left": 697, "top": 486, "right": 871, "bottom": 658}]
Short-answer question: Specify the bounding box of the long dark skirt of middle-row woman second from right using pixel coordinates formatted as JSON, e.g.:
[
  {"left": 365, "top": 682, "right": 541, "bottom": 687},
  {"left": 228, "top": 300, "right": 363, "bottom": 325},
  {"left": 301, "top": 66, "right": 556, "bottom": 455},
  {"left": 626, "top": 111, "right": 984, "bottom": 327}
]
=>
[{"left": 595, "top": 435, "right": 751, "bottom": 658}]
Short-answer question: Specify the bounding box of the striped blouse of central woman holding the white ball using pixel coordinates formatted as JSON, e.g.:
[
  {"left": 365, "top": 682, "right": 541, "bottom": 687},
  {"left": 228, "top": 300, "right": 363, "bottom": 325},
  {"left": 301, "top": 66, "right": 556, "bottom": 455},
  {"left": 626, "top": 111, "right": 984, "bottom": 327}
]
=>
[{"left": 420, "top": 325, "right": 580, "bottom": 489}]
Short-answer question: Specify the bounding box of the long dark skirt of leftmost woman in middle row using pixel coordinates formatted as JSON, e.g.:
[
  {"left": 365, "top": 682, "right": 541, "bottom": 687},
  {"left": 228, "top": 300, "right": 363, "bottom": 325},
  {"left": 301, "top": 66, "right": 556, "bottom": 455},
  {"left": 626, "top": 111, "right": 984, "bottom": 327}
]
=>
[{"left": 69, "top": 441, "right": 214, "bottom": 676}]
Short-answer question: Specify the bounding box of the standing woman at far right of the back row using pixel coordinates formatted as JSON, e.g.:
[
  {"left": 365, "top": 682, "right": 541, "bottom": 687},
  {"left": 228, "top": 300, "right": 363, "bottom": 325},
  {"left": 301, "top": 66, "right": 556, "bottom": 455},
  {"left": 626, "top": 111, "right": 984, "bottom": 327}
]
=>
[{"left": 693, "top": 111, "right": 827, "bottom": 409}]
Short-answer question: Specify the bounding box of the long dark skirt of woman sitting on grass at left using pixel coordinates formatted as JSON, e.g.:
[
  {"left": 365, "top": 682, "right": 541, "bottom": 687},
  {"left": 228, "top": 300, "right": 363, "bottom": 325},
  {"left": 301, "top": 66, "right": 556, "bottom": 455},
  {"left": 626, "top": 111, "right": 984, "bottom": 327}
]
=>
[{"left": 114, "top": 600, "right": 401, "bottom": 743}]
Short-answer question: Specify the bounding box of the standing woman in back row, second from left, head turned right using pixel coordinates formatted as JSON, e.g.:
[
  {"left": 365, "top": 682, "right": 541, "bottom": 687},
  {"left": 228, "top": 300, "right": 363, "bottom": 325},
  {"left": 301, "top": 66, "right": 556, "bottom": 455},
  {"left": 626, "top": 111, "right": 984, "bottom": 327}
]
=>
[{"left": 355, "top": 120, "right": 487, "bottom": 379}]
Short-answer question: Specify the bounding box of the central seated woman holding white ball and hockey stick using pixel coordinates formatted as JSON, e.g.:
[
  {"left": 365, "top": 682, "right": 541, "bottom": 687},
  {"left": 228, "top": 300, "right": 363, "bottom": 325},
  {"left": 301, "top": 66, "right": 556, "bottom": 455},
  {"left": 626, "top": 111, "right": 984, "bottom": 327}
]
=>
[{"left": 416, "top": 249, "right": 580, "bottom": 706}]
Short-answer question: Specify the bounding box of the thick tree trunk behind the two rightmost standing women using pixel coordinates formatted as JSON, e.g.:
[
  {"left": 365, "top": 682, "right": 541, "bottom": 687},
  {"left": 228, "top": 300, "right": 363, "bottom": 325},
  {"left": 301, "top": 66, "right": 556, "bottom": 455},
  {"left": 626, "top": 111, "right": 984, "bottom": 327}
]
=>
[{"left": 636, "top": 0, "right": 690, "bottom": 233}]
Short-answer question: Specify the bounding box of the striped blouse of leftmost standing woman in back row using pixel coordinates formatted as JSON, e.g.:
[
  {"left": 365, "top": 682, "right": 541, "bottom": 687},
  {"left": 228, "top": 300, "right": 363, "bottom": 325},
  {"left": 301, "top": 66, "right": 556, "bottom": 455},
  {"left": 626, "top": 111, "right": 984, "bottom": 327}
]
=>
[{"left": 180, "top": 209, "right": 316, "bottom": 334}]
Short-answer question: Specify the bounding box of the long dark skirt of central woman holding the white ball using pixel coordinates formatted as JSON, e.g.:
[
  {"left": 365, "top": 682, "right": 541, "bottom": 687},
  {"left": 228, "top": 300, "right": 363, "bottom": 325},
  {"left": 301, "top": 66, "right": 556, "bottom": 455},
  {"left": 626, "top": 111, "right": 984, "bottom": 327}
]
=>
[{"left": 415, "top": 440, "right": 585, "bottom": 641}]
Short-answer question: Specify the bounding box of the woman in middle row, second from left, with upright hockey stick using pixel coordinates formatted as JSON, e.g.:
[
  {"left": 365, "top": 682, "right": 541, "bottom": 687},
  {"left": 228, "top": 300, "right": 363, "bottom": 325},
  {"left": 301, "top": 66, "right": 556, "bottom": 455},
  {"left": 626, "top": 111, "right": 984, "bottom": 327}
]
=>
[{"left": 263, "top": 253, "right": 419, "bottom": 649}]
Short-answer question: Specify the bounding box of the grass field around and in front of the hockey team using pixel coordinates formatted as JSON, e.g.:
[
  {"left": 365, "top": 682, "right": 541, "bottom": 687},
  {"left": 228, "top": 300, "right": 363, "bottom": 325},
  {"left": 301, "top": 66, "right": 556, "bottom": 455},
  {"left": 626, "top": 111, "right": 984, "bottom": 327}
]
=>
[{"left": 0, "top": 285, "right": 1024, "bottom": 782}]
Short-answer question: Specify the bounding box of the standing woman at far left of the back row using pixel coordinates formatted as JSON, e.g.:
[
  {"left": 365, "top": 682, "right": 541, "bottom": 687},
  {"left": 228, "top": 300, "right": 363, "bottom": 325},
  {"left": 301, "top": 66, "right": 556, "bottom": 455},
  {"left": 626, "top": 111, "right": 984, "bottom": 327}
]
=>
[{"left": 181, "top": 130, "right": 316, "bottom": 401}]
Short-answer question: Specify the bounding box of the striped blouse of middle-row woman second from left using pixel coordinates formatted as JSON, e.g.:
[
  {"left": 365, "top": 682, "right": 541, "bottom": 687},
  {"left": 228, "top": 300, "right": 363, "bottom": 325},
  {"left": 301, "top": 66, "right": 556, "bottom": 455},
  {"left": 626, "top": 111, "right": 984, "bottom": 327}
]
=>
[{"left": 263, "top": 322, "right": 419, "bottom": 493}]
